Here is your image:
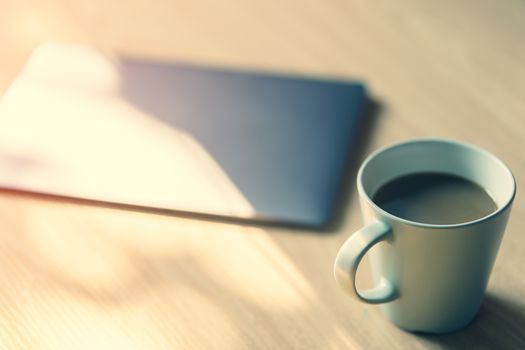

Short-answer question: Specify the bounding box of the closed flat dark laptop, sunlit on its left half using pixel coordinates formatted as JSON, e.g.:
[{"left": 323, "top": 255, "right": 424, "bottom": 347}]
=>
[{"left": 0, "top": 43, "right": 365, "bottom": 226}]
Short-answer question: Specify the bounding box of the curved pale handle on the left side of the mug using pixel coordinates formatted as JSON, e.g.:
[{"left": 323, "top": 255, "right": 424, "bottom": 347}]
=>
[{"left": 334, "top": 220, "right": 398, "bottom": 304}]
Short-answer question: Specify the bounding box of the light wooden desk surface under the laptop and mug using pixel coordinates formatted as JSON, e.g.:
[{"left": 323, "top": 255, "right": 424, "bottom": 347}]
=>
[{"left": 0, "top": 0, "right": 525, "bottom": 349}]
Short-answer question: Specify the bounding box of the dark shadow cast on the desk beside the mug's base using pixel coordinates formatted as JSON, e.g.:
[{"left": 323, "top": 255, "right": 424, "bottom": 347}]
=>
[{"left": 419, "top": 294, "right": 525, "bottom": 349}]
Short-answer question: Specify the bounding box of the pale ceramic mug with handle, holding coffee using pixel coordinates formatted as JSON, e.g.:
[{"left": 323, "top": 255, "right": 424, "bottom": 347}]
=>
[{"left": 334, "top": 139, "right": 516, "bottom": 333}]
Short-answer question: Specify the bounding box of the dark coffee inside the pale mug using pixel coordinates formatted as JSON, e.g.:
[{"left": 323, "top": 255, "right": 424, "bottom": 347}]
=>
[{"left": 373, "top": 172, "right": 497, "bottom": 225}]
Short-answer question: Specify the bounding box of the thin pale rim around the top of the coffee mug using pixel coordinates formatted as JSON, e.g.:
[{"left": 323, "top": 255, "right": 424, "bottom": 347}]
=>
[{"left": 357, "top": 137, "right": 516, "bottom": 229}]
